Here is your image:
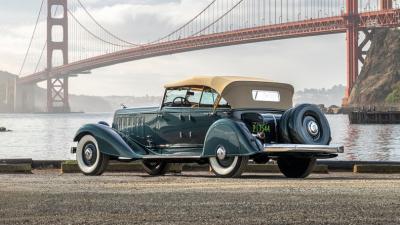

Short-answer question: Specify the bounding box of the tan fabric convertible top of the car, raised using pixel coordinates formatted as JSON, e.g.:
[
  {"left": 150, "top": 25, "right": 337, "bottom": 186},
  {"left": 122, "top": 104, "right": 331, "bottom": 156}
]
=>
[{"left": 164, "top": 76, "right": 294, "bottom": 109}]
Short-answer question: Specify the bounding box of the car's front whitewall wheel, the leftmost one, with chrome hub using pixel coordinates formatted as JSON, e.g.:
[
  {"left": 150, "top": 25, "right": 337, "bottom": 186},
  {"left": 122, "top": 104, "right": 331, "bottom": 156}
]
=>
[{"left": 76, "top": 135, "right": 109, "bottom": 176}]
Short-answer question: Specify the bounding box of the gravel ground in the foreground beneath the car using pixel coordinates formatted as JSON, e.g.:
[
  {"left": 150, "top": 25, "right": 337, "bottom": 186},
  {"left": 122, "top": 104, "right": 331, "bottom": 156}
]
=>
[{"left": 0, "top": 170, "right": 400, "bottom": 225}]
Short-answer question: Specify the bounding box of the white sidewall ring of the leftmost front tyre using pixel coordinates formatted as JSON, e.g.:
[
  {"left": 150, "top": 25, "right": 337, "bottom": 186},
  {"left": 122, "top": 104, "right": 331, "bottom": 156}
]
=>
[{"left": 76, "top": 135, "right": 101, "bottom": 173}]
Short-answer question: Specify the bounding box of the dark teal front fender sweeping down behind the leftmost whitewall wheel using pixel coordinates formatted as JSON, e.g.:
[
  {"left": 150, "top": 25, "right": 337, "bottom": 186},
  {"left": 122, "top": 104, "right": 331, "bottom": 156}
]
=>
[{"left": 74, "top": 124, "right": 146, "bottom": 159}]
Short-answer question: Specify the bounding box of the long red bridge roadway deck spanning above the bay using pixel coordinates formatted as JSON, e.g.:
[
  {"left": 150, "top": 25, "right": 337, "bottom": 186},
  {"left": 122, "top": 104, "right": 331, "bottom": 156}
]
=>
[{"left": 18, "top": 9, "right": 400, "bottom": 84}]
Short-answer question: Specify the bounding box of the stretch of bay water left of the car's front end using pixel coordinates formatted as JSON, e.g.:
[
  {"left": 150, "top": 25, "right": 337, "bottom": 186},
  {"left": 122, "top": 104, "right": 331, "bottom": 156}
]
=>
[{"left": 0, "top": 113, "right": 113, "bottom": 160}]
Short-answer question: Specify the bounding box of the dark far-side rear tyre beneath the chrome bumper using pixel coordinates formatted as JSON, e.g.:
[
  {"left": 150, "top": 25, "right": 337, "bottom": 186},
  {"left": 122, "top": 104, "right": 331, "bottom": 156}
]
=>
[{"left": 278, "top": 157, "right": 316, "bottom": 178}]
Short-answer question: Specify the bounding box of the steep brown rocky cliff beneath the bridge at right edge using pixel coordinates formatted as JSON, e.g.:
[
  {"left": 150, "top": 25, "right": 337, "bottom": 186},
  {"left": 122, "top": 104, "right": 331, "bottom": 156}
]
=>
[{"left": 349, "top": 29, "right": 400, "bottom": 107}]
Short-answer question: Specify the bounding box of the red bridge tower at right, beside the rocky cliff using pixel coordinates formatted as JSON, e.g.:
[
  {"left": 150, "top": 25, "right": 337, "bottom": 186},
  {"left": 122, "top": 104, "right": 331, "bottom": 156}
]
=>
[{"left": 343, "top": 0, "right": 393, "bottom": 106}]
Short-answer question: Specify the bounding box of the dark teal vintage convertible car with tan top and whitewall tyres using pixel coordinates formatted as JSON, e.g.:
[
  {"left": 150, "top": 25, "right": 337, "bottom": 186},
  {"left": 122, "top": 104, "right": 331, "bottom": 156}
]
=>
[{"left": 72, "top": 76, "right": 343, "bottom": 178}]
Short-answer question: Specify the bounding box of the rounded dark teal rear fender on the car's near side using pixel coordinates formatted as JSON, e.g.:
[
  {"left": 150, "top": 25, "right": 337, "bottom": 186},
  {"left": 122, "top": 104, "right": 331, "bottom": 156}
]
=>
[{"left": 202, "top": 118, "right": 263, "bottom": 157}]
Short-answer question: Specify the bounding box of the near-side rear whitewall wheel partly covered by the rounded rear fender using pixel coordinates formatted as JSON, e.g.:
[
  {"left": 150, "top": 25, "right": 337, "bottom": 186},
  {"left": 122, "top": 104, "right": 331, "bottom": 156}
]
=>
[{"left": 209, "top": 145, "right": 249, "bottom": 177}]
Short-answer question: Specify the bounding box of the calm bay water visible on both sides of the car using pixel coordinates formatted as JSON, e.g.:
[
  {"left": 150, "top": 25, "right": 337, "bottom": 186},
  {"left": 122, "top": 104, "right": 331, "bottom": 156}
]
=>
[{"left": 0, "top": 113, "right": 400, "bottom": 161}]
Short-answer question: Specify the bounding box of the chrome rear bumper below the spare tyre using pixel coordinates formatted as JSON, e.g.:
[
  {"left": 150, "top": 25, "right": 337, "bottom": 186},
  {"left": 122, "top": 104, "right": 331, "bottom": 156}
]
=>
[{"left": 264, "top": 144, "right": 344, "bottom": 154}]
